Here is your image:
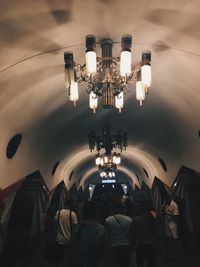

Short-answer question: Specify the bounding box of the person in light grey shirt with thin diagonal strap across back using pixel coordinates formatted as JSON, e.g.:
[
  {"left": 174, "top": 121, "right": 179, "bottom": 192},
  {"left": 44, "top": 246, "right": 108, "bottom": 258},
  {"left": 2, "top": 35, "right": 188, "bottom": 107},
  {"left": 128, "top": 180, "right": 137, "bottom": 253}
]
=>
[{"left": 105, "top": 203, "right": 132, "bottom": 267}]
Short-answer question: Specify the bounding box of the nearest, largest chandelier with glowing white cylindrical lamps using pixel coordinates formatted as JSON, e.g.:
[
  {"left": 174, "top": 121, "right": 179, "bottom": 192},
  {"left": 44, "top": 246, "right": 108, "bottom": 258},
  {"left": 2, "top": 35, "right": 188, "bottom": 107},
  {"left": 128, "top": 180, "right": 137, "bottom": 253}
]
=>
[{"left": 64, "top": 34, "right": 151, "bottom": 113}]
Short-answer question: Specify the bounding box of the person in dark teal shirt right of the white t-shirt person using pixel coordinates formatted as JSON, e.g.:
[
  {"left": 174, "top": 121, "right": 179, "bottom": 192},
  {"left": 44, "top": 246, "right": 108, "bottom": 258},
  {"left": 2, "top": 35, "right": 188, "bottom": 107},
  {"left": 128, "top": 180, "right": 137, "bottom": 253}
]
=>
[{"left": 67, "top": 201, "right": 111, "bottom": 267}]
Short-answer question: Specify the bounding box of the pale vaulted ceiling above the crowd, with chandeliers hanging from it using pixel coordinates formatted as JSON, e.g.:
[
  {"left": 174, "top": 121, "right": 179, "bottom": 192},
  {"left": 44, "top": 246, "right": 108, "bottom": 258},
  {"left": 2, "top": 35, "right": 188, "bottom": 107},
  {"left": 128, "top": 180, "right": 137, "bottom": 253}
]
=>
[{"left": 0, "top": 0, "right": 200, "bottom": 189}]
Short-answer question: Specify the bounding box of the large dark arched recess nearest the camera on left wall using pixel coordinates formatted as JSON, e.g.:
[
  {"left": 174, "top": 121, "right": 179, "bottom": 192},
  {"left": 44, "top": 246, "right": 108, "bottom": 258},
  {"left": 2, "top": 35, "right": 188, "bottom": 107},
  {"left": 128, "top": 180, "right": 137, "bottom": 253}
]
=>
[{"left": 8, "top": 171, "right": 49, "bottom": 236}]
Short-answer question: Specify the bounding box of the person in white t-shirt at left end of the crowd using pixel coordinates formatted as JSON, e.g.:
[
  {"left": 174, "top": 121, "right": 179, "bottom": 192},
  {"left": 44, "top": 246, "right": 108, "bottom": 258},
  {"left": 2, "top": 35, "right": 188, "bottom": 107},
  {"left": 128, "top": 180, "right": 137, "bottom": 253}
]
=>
[{"left": 54, "top": 199, "right": 78, "bottom": 262}]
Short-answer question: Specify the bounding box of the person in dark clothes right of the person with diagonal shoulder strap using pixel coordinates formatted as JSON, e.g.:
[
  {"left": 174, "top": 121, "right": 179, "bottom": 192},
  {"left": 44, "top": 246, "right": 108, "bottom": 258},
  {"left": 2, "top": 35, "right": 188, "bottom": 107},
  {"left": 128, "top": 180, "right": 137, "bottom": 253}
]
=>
[{"left": 132, "top": 209, "right": 158, "bottom": 267}]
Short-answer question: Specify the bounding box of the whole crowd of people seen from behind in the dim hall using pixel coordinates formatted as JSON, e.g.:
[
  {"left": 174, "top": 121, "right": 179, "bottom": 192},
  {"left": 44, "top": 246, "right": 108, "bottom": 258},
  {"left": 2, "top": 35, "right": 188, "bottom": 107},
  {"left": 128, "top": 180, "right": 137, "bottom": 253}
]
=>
[{"left": 44, "top": 191, "right": 180, "bottom": 267}]
